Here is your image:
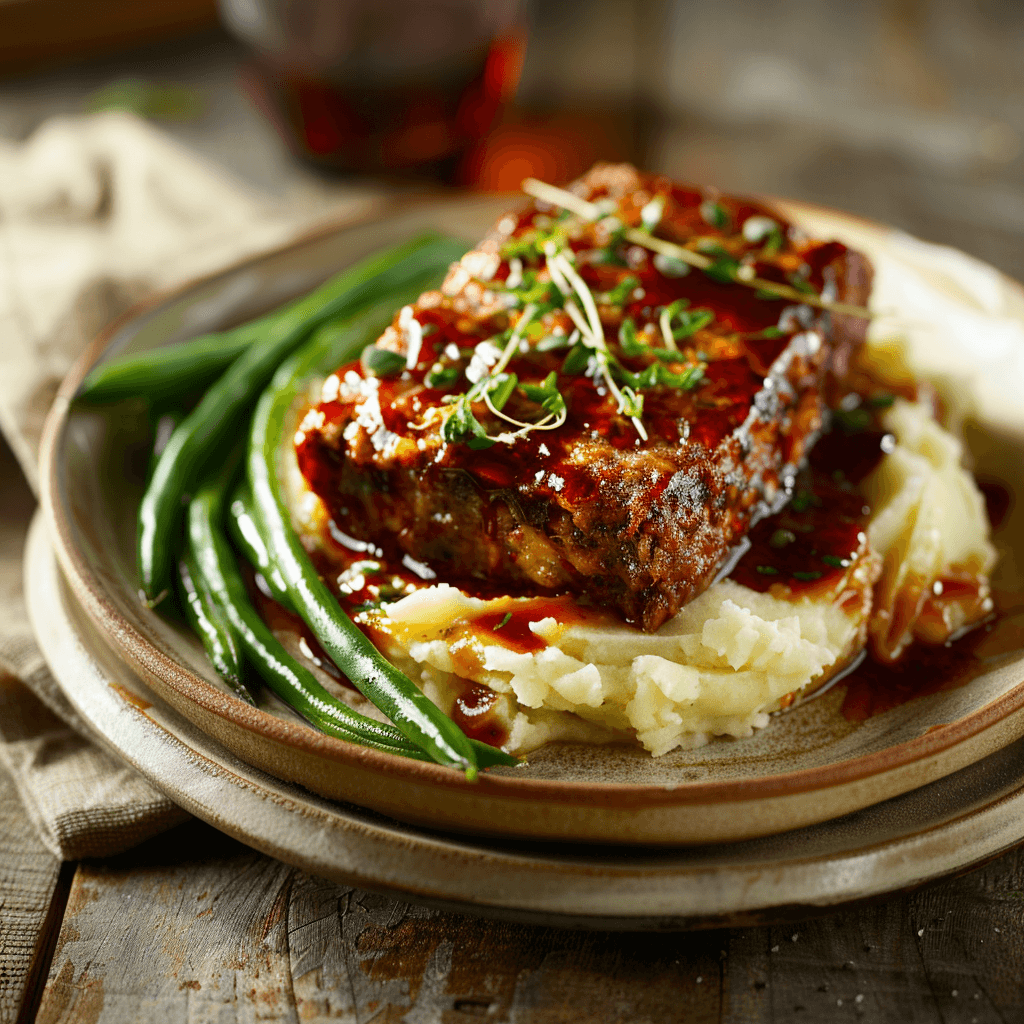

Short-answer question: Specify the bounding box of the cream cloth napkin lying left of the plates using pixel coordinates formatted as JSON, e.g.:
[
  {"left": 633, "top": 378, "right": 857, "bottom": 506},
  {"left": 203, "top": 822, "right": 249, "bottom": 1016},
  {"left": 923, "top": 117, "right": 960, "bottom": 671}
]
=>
[{"left": 0, "top": 114, "right": 379, "bottom": 860}]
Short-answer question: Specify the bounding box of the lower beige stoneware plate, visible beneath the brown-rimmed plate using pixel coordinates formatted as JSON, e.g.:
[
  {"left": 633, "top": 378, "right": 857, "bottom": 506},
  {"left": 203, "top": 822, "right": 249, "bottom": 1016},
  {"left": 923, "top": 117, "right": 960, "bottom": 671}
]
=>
[{"left": 25, "top": 517, "right": 1024, "bottom": 930}]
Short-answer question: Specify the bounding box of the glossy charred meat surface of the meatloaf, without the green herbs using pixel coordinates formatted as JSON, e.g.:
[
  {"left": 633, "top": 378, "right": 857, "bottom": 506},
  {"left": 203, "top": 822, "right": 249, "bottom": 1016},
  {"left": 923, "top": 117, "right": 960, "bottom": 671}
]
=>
[{"left": 297, "top": 165, "right": 871, "bottom": 630}]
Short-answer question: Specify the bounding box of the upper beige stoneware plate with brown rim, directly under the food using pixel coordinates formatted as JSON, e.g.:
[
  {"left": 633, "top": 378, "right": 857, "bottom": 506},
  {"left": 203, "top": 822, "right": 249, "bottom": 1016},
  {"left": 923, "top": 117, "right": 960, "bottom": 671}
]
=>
[{"left": 42, "top": 200, "right": 1024, "bottom": 845}]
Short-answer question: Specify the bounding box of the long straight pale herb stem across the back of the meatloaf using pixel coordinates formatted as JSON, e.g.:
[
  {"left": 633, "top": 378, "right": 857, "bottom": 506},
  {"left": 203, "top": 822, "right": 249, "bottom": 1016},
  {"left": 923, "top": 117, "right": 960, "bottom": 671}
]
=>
[{"left": 522, "top": 178, "right": 874, "bottom": 319}]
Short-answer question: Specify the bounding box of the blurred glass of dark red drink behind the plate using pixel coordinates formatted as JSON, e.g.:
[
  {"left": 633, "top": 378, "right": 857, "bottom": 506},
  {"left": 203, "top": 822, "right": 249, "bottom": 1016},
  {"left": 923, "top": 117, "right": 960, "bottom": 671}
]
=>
[{"left": 221, "top": 0, "right": 523, "bottom": 180}]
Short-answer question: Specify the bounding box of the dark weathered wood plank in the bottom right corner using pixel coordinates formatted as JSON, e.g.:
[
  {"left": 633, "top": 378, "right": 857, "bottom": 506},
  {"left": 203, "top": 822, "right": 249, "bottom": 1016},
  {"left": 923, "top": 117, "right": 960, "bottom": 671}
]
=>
[{"left": 724, "top": 851, "right": 1024, "bottom": 1024}]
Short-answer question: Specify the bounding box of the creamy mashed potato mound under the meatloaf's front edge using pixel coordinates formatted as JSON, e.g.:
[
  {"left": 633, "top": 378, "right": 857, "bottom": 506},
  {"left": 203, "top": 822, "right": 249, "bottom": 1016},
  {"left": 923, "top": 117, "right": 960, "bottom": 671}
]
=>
[{"left": 378, "top": 580, "right": 862, "bottom": 756}]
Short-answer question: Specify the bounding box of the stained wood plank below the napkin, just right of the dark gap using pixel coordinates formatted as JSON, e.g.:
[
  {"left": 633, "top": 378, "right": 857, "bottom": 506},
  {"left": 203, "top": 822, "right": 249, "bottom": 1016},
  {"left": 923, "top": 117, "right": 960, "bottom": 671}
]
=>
[{"left": 38, "top": 827, "right": 297, "bottom": 1024}]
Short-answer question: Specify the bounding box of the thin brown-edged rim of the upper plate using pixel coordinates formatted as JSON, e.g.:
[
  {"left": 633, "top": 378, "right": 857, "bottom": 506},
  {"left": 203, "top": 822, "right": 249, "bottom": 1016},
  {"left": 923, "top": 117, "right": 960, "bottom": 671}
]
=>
[{"left": 40, "top": 196, "right": 1024, "bottom": 808}]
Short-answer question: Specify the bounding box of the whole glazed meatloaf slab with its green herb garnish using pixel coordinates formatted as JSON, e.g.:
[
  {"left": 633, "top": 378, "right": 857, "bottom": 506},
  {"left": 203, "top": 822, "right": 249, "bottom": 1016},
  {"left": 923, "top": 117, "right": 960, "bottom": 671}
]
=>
[{"left": 296, "top": 165, "right": 871, "bottom": 630}]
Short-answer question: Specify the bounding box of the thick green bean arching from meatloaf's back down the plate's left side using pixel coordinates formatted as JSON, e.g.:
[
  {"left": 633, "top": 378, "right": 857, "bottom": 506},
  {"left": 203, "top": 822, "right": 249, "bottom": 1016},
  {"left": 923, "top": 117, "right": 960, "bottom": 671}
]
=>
[{"left": 137, "top": 236, "right": 463, "bottom": 605}]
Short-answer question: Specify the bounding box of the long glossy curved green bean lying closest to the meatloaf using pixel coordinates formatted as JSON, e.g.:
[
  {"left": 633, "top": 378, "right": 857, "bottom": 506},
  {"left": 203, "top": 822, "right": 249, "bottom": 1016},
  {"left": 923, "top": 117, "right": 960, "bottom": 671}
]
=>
[{"left": 248, "top": 306, "right": 476, "bottom": 778}]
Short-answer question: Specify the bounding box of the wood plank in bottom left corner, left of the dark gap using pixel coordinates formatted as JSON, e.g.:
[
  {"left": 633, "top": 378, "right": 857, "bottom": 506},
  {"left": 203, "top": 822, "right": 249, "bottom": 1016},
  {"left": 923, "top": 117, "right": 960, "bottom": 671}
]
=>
[{"left": 0, "top": 769, "right": 60, "bottom": 1024}]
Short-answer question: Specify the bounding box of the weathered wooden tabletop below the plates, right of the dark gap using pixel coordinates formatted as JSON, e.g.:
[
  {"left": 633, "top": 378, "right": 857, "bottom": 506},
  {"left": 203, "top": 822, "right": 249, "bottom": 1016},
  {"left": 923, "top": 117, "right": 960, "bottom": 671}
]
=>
[{"left": 32, "top": 822, "right": 1024, "bottom": 1024}]
